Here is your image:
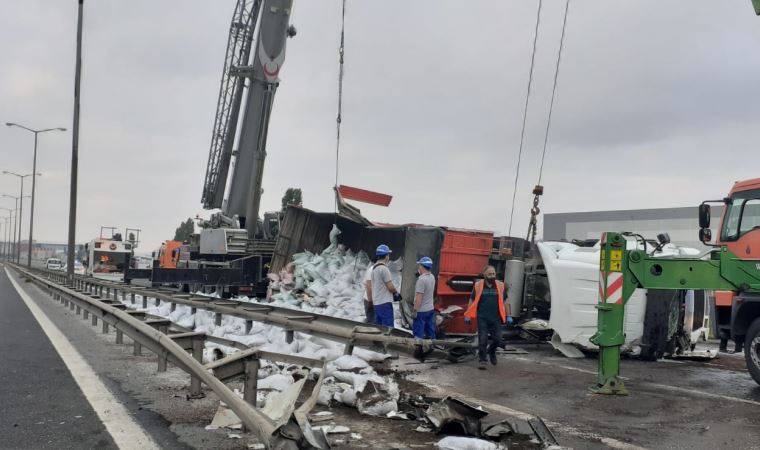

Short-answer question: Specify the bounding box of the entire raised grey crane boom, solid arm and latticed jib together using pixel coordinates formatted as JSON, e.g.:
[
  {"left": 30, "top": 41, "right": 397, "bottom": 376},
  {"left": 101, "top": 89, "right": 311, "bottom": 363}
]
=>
[{"left": 201, "top": 0, "right": 296, "bottom": 239}]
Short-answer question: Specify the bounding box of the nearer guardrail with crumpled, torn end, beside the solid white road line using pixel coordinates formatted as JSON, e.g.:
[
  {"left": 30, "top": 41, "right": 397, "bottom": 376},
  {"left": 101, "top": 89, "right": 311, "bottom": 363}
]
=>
[{"left": 8, "top": 264, "right": 328, "bottom": 449}]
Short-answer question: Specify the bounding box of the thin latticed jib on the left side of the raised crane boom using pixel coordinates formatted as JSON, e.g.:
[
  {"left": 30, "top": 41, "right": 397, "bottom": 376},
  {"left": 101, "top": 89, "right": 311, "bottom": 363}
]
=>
[{"left": 201, "top": 0, "right": 261, "bottom": 209}]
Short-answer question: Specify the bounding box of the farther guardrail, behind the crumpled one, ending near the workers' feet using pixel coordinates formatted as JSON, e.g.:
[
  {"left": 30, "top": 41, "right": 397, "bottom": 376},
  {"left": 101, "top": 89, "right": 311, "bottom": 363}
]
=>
[{"left": 37, "top": 269, "right": 476, "bottom": 361}]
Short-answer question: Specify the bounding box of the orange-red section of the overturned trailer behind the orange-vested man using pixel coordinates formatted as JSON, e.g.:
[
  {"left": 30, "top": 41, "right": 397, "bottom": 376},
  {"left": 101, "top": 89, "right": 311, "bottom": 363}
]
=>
[{"left": 436, "top": 228, "right": 493, "bottom": 334}]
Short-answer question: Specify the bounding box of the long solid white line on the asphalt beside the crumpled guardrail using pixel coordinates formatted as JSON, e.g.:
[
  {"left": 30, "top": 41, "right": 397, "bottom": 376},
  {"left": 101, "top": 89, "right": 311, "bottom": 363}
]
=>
[{"left": 5, "top": 268, "right": 160, "bottom": 450}]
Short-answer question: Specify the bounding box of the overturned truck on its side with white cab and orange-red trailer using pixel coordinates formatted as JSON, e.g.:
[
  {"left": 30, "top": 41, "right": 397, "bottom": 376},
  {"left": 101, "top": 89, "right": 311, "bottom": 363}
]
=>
[{"left": 270, "top": 206, "right": 709, "bottom": 359}]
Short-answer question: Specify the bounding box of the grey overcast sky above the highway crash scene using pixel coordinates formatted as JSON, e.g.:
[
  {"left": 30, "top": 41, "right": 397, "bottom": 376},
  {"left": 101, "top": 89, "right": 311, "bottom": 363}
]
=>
[{"left": 0, "top": 0, "right": 760, "bottom": 252}]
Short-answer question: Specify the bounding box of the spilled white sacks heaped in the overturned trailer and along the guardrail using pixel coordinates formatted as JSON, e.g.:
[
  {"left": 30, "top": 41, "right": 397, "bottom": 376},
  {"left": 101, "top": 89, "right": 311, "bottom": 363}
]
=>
[{"left": 117, "top": 228, "right": 401, "bottom": 426}]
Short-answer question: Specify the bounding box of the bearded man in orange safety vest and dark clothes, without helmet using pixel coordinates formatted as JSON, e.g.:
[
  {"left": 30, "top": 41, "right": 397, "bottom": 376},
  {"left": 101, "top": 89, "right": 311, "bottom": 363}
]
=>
[{"left": 464, "top": 266, "right": 512, "bottom": 370}]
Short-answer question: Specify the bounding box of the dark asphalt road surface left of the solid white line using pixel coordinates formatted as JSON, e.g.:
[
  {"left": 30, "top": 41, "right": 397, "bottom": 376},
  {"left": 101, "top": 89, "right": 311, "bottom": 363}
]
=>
[{"left": 0, "top": 269, "right": 116, "bottom": 449}]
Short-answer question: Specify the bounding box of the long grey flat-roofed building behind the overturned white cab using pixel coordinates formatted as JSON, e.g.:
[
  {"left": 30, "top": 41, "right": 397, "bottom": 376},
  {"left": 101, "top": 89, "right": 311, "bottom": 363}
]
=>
[{"left": 543, "top": 206, "right": 723, "bottom": 249}]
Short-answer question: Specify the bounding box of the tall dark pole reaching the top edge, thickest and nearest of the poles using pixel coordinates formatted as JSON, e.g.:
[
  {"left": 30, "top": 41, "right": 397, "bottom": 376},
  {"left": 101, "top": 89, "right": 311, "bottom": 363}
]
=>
[{"left": 66, "top": 0, "right": 84, "bottom": 283}]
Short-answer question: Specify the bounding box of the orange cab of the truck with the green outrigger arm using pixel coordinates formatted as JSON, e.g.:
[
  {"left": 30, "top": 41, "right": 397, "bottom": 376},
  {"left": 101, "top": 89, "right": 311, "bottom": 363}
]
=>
[{"left": 700, "top": 178, "right": 760, "bottom": 351}]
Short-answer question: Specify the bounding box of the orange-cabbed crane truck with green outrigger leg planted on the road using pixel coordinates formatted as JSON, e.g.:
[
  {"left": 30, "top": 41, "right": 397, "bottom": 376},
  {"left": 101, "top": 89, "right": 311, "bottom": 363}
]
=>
[{"left": 591, "top": 177, "right": 760, "bottom": 395}]
